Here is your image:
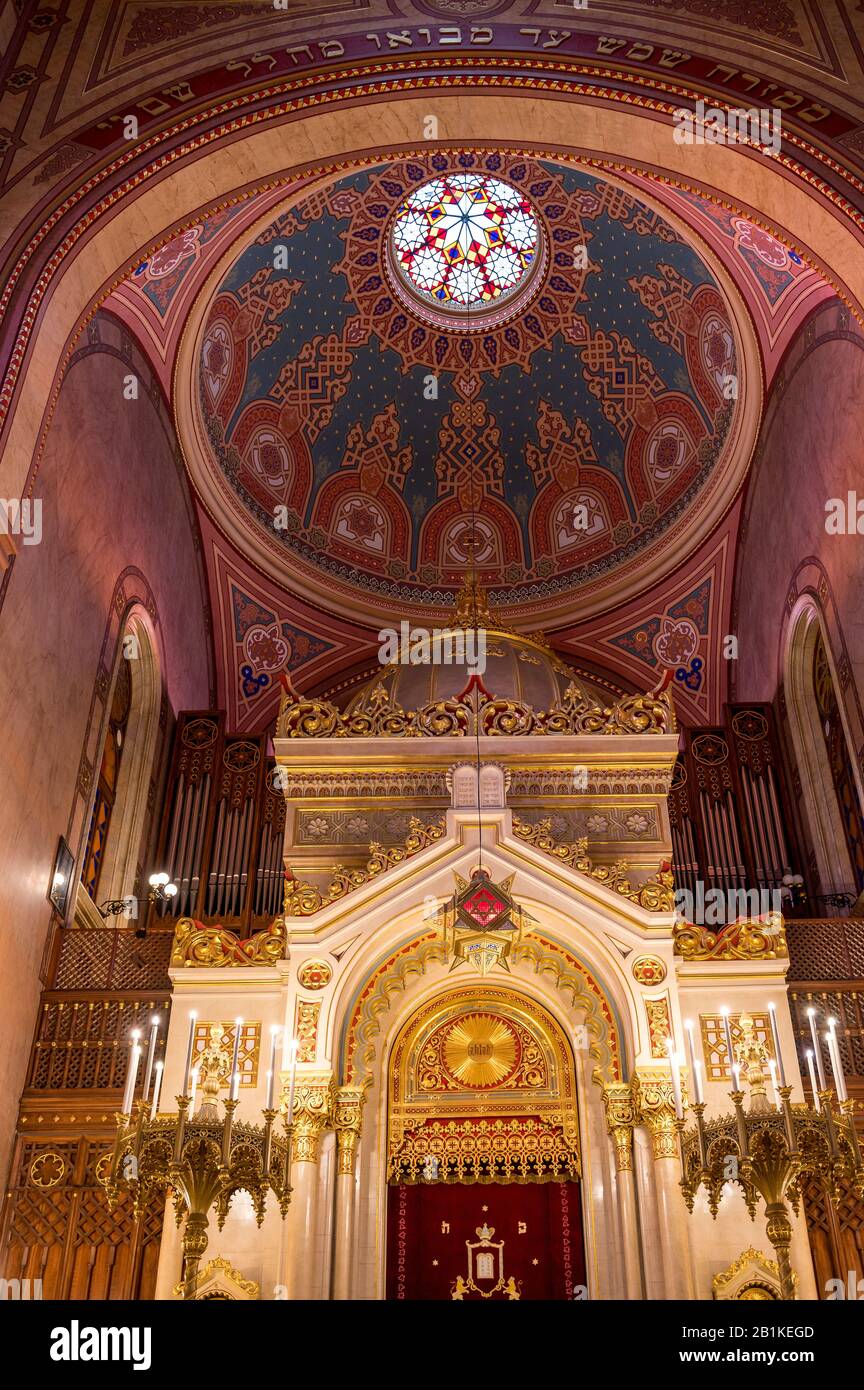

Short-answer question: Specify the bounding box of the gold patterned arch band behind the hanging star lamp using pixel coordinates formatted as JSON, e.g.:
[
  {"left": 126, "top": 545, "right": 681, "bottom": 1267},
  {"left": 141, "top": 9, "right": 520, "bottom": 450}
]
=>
[{"left": 339, "top": 931, "right": 625, "bottom": 1086}]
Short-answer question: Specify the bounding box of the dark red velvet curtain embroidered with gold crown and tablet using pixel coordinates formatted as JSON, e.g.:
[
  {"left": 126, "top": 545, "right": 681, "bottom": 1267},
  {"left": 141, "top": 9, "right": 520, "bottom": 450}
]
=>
[{"left": 388, "top": 1182, "right": 585, "bottom": 1302}]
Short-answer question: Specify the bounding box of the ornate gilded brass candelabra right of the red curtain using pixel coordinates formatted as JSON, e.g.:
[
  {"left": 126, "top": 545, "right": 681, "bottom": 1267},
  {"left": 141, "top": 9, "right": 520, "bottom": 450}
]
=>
[{"left": 675, "top": 1015, "right": 864, "bottom": 1300}]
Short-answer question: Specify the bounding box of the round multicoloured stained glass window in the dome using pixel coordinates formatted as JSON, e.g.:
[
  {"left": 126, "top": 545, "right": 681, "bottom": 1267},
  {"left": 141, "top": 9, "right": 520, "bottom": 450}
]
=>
[{"left": 390, "top": 174, "right": 539, "bottom": 310}]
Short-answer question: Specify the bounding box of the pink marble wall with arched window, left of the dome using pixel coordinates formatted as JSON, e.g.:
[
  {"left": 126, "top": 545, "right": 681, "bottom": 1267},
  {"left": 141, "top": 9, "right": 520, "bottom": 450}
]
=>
[{"left": 0, "top": 316, "right": 211, "bottom": 1175}]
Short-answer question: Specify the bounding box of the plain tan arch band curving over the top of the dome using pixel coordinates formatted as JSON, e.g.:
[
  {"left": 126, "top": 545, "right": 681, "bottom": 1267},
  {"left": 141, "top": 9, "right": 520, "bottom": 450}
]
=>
[{"left": 0, "top": 75, "right": 864, "bottom": 495}]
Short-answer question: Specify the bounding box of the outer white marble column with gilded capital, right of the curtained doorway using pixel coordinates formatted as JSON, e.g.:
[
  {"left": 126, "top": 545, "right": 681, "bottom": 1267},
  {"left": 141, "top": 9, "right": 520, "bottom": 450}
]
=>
[{"left": 633, "top": 1068, "right": 696, "bottom": 1300}]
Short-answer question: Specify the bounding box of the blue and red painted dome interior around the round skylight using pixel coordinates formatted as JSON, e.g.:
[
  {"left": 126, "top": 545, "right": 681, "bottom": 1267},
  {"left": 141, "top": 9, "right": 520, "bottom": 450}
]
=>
[{"left": 191, "top": 152, "right": 746, "bottom": 625}]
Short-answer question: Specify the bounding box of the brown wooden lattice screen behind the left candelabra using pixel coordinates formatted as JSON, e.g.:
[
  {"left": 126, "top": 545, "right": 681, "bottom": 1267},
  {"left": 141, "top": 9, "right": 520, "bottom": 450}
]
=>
[{"left": 0, "top": 927, "right": 172, "bottom": 1298}]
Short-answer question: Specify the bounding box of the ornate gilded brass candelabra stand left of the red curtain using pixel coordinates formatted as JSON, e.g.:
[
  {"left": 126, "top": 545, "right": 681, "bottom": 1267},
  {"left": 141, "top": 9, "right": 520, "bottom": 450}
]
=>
[{"left": 106, "top": 1083, "right": 294, "bottom": 1298}]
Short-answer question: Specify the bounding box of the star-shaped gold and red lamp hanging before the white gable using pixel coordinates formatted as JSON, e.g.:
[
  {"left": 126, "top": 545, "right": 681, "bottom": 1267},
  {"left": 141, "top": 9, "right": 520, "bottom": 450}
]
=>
[{"left": 439, "top": 867, "right": 532, "bottom": 974}]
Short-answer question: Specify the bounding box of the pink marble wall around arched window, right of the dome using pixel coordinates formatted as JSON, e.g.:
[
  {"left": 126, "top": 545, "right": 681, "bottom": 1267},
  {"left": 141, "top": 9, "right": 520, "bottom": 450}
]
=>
[{"left": 733, "top": 300, "right": 864, "bottom": 717}]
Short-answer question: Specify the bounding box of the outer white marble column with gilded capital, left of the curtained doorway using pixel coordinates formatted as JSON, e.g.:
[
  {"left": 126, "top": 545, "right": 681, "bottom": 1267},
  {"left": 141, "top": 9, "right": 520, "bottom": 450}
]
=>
[{"left": 282, "top": 1072, "right": 336, "bottom": 1298}]
